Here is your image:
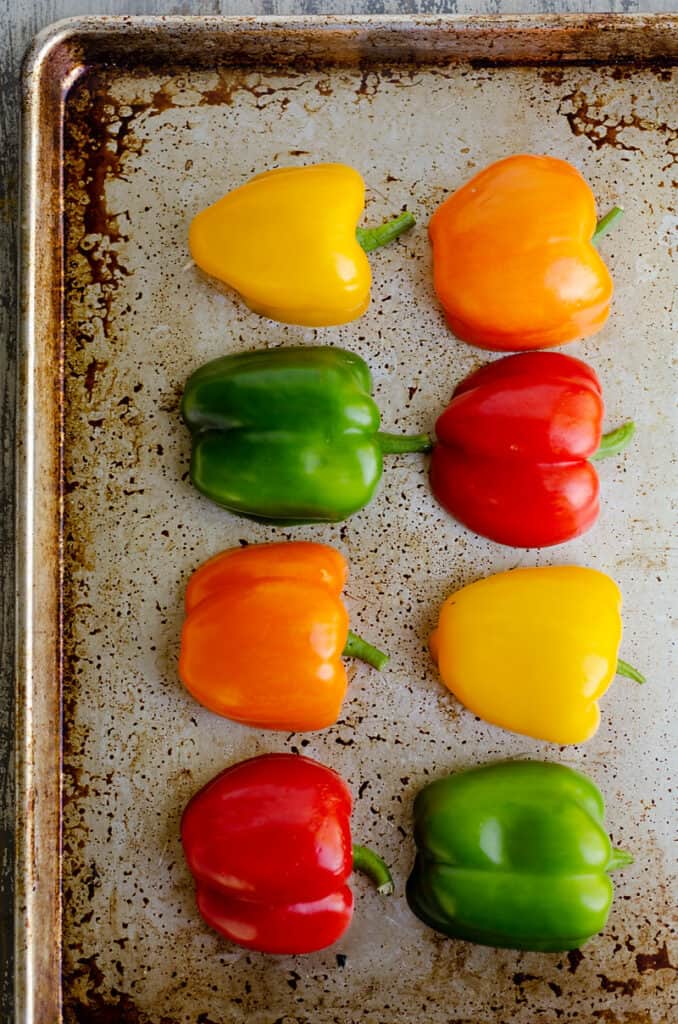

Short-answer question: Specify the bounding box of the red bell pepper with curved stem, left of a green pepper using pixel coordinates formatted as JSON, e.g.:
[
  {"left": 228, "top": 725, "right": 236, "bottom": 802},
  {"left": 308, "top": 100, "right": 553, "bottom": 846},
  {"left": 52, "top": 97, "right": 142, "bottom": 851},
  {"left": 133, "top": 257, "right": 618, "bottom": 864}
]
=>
[{"left": 181, "top": 754, "right": 392, "bottom": 953}]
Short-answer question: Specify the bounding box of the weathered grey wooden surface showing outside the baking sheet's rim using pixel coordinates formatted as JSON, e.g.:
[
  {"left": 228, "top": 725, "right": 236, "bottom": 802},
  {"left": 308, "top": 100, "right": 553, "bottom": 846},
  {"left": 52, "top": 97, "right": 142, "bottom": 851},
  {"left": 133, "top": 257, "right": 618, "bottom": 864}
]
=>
[{"left": 13, "top": 9, "right": 675, "bottom": 1022}]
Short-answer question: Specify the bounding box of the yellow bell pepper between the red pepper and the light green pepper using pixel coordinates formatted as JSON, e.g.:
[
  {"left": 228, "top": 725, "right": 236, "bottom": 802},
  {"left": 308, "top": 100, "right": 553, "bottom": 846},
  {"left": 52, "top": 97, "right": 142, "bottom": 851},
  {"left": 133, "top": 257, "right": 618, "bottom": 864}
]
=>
[{"left": 429, "top": 565, "right": 644, "bottom": 743}]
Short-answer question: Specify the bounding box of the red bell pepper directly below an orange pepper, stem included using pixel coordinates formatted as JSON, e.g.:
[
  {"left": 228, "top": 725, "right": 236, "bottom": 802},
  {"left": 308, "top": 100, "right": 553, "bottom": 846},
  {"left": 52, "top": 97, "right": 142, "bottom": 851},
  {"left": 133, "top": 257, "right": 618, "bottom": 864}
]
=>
[{"left": 430, "top": 352, "right": 635, "bottom": 548}]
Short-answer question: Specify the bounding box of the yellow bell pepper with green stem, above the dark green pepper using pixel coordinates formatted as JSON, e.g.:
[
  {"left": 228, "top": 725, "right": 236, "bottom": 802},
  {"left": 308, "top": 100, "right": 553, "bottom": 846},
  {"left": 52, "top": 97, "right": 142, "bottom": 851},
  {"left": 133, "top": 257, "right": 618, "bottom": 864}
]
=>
[{"left": 188, "top": 164, "right": 415, "bottom": 327}]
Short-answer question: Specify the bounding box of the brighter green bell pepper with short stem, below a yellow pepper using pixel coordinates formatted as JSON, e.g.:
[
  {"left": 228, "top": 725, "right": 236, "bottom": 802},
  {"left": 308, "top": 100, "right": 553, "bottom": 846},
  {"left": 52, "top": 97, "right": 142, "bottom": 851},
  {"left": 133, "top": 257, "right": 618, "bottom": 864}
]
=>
[{"left": 407, "top": 761, "right": 633, "bottom": 952}]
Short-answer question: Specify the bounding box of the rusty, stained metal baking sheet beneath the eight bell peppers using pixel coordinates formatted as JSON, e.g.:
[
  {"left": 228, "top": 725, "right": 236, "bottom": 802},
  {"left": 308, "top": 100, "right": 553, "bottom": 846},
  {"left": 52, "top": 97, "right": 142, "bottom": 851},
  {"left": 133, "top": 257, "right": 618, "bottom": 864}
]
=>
[{"left": 16, "top": 15, "right": 678, "bottom": 1024}]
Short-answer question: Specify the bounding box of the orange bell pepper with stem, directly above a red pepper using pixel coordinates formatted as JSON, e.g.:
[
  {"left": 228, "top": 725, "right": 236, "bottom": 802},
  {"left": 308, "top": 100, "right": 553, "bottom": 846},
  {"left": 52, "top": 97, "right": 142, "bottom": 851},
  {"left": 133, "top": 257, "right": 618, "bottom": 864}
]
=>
[{"left": 179, "top": 541, "right": 387, "bottom": 732}]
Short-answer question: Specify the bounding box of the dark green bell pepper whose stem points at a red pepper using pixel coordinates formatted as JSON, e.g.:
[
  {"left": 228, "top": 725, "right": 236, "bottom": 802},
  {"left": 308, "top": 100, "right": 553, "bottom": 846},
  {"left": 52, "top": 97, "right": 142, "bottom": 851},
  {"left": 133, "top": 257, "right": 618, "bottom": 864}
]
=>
[{"left": 181, "top": 346, "right": 431, "bottom": 523}]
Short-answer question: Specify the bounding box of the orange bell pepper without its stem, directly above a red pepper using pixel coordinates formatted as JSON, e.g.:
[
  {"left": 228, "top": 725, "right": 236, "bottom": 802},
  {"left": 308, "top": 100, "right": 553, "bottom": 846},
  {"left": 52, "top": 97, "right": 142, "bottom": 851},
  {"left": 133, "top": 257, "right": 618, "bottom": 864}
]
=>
[{"left": 429, "top": 155, "right": 612, "bottom": 351}]
